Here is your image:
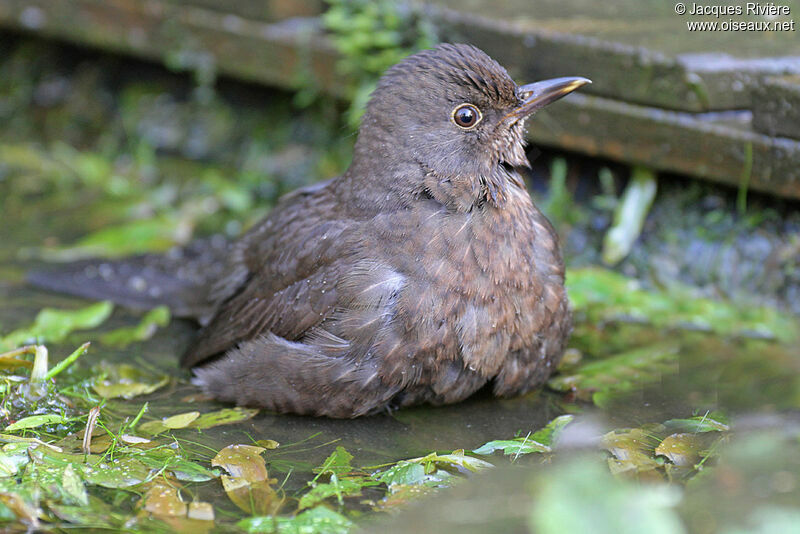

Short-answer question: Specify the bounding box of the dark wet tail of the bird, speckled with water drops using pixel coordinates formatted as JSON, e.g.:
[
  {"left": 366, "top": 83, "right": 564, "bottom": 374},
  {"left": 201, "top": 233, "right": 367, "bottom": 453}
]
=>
[{"left": 27, "top": 238, "right": 229, "bottom": 321}]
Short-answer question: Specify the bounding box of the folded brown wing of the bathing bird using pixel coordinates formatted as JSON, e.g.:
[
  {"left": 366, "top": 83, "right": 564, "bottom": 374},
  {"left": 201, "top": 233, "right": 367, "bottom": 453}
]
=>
[{"left": 182, "top": 182, "right": 353, "bottom": 366}]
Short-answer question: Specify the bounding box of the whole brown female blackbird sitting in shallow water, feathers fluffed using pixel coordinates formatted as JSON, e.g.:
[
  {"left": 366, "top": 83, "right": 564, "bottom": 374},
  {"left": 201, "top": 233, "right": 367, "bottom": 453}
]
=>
[{"left": 32, "top": 44, "right": 589, "bottom": 418}]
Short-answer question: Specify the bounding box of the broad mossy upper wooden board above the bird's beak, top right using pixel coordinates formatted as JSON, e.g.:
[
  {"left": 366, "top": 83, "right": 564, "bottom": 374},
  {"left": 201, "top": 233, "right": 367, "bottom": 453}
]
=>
[{"left": 428, "top": 0, "right": 800, "bottom": 112}]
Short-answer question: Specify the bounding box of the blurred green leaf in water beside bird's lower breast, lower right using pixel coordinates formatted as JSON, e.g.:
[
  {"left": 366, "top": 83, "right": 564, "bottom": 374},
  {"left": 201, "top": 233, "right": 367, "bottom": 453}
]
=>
[{"left": 547, "top": 343, "right": 678, "bottom": 406}]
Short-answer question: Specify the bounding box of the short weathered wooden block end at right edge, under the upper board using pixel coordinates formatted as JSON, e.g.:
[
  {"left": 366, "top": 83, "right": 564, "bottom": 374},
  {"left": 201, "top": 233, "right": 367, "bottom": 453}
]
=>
[{"left": 753, "top": 76, "right": 800, "bottom": 139}]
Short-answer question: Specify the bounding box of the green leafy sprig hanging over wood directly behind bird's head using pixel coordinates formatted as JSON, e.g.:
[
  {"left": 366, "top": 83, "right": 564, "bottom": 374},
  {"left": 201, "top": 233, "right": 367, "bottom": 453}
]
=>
[{"left": 323, "top": 0, "right": 438, "bottom": 130}]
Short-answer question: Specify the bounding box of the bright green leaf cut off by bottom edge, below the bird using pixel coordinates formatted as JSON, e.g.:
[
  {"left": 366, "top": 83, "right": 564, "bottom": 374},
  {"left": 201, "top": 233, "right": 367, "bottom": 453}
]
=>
[{"left": 236, "top": 506, "right": 354, "bottom": 534}]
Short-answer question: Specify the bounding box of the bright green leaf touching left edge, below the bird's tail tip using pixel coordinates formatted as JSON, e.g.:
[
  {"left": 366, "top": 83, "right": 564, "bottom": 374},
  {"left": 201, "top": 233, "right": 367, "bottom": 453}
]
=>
[{"left": 0, "top": 302, "right": 114, "bottom": 350}]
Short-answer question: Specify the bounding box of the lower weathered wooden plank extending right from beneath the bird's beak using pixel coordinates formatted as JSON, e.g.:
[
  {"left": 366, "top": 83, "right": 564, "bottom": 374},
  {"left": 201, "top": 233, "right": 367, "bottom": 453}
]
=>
[{"left": 528, "top": 94, "right": 800, "bottom": 198}]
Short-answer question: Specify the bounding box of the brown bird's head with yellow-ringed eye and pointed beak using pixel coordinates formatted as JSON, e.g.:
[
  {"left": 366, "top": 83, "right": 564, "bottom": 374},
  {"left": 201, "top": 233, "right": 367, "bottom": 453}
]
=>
[{"left": 354, "top": 44, "right": 590, "bottom": 211}]
